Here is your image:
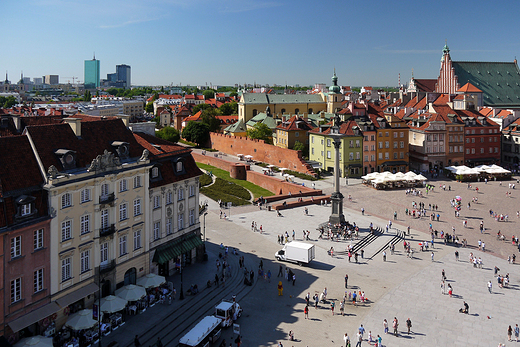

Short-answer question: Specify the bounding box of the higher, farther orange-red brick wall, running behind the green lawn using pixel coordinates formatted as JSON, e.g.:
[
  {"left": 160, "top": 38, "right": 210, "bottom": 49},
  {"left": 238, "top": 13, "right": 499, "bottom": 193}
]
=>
[{"left": 211, "top": 133, "right": 315, "bottom": 175}]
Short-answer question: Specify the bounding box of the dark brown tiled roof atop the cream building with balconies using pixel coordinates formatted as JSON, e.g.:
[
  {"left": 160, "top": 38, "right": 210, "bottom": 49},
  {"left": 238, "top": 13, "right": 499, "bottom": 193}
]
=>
[{"left": 26, "top": 119, "right": 143, "bottom": 172}]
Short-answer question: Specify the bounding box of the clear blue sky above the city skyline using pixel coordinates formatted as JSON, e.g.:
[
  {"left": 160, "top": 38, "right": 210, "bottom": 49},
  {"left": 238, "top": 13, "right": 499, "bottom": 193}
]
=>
[{"left": 0, "top": 0, "right": 520, "bottom": 87}]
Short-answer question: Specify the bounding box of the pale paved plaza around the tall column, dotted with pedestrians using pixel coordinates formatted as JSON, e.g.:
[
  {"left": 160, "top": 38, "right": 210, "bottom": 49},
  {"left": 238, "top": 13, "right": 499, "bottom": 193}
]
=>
[{"left": 206, "top": 173, "right": 520, "bottom": 346}]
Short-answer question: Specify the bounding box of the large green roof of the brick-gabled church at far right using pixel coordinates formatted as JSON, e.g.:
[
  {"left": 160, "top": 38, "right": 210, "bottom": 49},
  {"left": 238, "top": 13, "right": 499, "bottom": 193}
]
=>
[{"left": 453, "top": 61, "right": 520, "bottom": 107}]
